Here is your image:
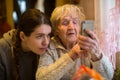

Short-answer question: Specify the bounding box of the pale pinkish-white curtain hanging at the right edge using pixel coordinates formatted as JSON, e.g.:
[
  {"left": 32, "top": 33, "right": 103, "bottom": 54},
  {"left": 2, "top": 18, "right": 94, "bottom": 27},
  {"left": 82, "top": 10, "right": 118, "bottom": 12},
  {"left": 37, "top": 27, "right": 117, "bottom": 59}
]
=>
[{"left": 94, "top": 0, "right": 120, "bottom": 68}]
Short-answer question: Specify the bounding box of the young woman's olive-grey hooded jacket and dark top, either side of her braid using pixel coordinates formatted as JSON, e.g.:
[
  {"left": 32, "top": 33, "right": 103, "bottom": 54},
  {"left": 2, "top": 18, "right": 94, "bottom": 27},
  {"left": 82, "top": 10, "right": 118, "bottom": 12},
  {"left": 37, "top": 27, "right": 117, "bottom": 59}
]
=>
[{"left": 0, "top": 30, "right": 37, "bottom": 80}]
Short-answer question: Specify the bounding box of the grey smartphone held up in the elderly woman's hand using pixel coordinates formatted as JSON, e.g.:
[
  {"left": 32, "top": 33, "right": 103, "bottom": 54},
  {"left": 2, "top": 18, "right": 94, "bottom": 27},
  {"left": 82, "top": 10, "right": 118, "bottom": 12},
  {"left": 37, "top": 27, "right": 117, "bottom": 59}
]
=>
[{"left": 81, "top": 20, "right": 94, "bottom": 36}]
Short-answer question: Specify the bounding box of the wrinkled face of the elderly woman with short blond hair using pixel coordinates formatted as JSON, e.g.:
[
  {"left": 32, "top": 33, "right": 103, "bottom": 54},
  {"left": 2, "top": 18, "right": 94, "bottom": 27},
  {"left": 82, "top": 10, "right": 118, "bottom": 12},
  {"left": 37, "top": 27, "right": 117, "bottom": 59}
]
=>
[{"left": 57, "top": 13, "right": 81, "bottom": 45}]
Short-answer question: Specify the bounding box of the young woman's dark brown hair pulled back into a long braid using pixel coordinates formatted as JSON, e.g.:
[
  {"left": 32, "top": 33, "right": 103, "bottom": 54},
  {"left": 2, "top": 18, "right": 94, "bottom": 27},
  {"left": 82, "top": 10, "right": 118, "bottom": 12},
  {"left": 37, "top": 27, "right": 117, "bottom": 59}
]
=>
[{"left": 13, "top": 9, "right": 51, "bottom": 80}]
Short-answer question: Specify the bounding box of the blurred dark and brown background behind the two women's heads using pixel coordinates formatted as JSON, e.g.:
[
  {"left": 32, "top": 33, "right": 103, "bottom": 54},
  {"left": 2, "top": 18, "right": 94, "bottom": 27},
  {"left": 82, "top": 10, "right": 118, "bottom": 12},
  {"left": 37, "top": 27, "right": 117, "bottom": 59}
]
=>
[{"left": 0, "top": 0, "right": 94, "bottom": 28}]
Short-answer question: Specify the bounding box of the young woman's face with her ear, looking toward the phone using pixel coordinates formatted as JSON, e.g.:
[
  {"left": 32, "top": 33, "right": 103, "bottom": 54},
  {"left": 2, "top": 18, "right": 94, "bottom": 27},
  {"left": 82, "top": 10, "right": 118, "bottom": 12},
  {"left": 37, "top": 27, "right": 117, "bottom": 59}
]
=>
[{"left": 21, "top": 24, "right": 51, "bottom": 54}]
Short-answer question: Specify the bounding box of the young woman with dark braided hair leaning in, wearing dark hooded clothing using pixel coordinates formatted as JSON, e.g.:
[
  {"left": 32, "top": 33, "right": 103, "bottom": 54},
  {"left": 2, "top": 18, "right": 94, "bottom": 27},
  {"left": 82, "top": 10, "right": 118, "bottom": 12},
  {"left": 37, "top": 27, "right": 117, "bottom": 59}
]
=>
[{"left": 0, "top": 9, "right": 51, "bottom": 80}]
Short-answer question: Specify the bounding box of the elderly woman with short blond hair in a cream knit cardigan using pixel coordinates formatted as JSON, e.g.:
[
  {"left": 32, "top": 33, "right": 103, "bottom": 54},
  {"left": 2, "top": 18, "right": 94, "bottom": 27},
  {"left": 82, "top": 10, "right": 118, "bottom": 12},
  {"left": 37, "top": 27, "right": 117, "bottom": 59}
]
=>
[{"left": 36, "top": 4, "right": 114, "bottom": 80}]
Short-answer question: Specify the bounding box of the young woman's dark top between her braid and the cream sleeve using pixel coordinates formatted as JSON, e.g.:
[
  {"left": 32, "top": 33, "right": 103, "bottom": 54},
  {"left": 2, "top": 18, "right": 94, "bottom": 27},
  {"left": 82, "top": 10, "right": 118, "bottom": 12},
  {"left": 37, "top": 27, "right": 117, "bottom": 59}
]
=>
[{"left": 18, "top": 52, "right": 37, "bottom": 80}]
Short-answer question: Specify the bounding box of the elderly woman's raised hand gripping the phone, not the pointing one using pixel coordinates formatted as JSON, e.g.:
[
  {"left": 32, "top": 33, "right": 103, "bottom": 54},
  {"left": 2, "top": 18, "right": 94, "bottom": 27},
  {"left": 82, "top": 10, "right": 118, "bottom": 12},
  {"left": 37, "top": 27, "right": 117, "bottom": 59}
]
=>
[{"left": 78, "top": 30, "right": 102, "bottom": 61}]
